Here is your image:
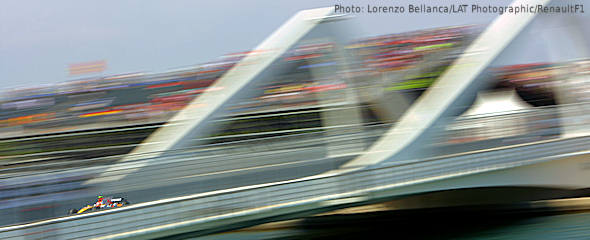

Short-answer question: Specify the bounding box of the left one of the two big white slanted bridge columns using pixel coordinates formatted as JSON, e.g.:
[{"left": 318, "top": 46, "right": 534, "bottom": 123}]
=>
[{"left": 86, "top": 7, "right": 340, "bottom": 184}]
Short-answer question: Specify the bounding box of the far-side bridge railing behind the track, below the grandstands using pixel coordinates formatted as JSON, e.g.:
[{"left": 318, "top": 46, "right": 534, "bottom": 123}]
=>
[{"left": 0, "top": 100, "right": 590, "bottom": 179}]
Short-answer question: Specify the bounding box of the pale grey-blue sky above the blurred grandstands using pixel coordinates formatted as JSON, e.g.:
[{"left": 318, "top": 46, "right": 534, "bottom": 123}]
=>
[{"left": 0, "top": 0, "right": 590, "bottom": 90}]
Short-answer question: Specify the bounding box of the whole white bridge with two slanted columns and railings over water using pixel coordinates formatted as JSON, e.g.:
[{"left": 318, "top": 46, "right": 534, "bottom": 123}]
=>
[{"left": 0, "top": 0, "right": 590, "bottom": 239}]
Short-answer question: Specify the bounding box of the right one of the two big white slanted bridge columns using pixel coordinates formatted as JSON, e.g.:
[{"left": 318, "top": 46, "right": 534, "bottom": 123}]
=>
[{"left": 335, "top": 0, "right": 550, "bottom": 172}]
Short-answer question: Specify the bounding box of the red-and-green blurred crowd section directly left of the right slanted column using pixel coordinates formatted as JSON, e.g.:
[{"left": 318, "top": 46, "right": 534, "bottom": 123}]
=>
[{"left": 347, "top": 26, "right": 479, "bottom": 95}]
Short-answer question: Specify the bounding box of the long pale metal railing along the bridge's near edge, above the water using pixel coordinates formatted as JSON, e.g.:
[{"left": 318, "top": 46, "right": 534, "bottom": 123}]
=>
[{"left": 0, "top": 134, "right": 590, "bottom": 239}]
